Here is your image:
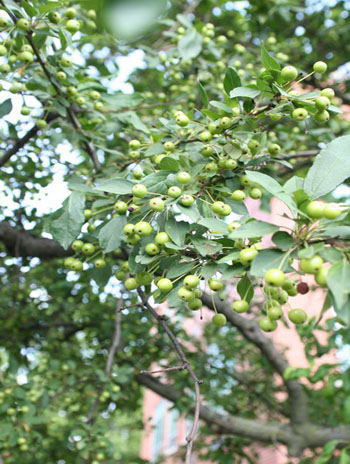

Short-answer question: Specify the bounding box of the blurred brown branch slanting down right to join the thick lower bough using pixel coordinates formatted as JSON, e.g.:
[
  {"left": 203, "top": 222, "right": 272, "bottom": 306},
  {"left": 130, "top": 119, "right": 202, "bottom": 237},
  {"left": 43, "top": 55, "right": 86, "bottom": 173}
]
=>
[{"left": 202, "top": 293, "right": 308, "bottom": 426}]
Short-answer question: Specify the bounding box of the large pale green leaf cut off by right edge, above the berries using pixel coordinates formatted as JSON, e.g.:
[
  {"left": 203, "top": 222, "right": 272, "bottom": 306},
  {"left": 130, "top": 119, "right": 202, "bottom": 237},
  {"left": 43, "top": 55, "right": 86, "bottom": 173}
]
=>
[{"left": 305, "top": 135, "right": 350, "bottom": 200}]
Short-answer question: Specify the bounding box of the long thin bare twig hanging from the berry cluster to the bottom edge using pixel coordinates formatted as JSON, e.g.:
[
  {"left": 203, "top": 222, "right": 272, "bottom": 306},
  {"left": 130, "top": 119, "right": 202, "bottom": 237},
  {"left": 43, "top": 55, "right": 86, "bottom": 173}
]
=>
[{"left": 137, "top": 288, "right": 201, "bottom": 464}]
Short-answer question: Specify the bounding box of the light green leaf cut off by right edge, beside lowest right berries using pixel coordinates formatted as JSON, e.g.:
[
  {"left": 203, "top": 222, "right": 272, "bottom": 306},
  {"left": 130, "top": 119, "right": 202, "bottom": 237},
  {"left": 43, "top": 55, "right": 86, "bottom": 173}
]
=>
[{"left": 327, "top": 260, "right": 350, "bottom": 309}]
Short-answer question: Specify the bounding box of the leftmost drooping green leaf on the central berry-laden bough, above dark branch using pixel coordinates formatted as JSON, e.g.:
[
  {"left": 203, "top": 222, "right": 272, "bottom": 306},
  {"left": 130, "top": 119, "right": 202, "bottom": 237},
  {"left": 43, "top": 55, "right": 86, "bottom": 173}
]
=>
[{"left": 50, "top": 192, "right": 85, "bottom": 249}]
